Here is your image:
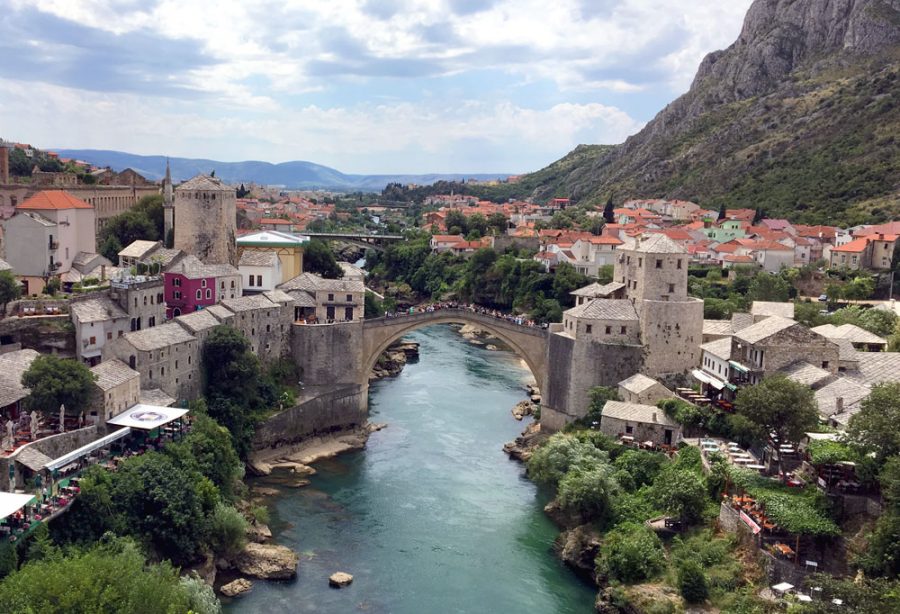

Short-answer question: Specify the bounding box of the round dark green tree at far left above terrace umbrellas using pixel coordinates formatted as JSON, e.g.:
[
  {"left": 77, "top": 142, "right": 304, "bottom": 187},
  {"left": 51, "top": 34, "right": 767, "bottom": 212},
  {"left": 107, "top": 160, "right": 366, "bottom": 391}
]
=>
[{"left": 22, "top": 354, "right": 96, "bottom": 416}]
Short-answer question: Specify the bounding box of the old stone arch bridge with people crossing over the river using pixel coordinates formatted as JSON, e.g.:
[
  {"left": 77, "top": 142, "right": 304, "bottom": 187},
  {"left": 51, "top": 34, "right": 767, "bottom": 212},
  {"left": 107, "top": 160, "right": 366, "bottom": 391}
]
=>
[{"left": 360, "top": 309, "right": 547, "bottom": 390}]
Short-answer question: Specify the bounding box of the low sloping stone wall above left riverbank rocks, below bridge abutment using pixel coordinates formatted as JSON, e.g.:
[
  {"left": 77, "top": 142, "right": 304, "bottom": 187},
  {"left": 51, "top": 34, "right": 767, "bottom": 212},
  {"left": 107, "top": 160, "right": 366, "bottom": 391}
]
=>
[{"left": 253, "top": 385, "right": 368, "bottom": 450}]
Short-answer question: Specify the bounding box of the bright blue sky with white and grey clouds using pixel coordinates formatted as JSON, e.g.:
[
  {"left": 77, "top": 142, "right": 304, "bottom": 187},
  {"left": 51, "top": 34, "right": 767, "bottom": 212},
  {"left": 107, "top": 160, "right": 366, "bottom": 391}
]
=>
[{"left": 0, "top": 0, "right": 751, "bottom": 174}]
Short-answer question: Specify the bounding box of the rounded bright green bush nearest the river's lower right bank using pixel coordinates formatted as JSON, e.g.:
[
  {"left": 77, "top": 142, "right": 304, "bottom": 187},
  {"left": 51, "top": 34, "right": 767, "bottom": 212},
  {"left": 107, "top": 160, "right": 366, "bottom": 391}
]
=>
[{"left": 596, "top": 522, "right": 665, "bottom": 584}]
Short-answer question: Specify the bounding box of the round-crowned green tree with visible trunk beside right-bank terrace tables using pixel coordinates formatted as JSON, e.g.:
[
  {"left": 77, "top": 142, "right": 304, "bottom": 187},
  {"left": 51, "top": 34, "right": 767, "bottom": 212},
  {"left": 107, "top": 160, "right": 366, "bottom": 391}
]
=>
[{"left": 735, "top": 374, "right": 819, "bottom": 482}]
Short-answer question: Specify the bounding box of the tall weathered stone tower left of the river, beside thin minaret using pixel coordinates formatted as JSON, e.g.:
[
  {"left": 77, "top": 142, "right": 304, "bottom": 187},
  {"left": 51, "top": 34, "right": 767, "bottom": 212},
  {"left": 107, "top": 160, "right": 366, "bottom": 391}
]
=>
[{"left": 174, "top": 175, "right": 237, "bottom": 266}]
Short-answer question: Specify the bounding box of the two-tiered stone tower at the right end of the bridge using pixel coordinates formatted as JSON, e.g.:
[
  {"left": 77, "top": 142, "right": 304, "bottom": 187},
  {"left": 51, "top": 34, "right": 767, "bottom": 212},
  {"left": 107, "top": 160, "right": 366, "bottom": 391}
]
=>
[{"left": 613, "top": 234, "right": 703, "bottom": 377}]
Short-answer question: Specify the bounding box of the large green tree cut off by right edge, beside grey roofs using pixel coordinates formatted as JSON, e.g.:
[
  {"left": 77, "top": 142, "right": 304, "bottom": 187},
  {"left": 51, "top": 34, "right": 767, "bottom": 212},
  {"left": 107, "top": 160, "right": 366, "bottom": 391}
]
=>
[{"left": 847, "top": 382, "right": 900, "bottom": 464}]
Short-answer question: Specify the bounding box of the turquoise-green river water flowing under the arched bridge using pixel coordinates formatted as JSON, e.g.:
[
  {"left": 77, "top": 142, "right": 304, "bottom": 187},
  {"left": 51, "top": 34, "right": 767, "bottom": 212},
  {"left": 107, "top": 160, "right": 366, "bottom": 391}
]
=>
[{"left": 226, "top": 326, "right": 596, "bottom": 614}]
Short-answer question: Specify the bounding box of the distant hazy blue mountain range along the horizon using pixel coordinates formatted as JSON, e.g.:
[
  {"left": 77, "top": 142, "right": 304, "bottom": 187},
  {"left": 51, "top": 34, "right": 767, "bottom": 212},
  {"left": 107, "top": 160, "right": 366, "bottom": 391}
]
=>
[{"left": 53, "top": 149, "right": 509, "bottom": 192}]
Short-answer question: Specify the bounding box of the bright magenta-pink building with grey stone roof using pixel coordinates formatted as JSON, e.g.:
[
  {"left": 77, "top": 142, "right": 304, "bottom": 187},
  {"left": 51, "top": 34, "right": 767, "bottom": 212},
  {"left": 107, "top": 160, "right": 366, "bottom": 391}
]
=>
[{"left": 163, "top": 256, "right": 242, "bottom": 319}]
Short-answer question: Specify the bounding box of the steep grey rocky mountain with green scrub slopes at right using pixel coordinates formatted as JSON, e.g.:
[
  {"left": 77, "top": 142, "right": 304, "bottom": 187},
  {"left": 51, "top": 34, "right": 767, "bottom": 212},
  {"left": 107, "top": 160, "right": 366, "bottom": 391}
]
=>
[{"left": 522, "top": 0, "right": 900, "bottom": 223}]
